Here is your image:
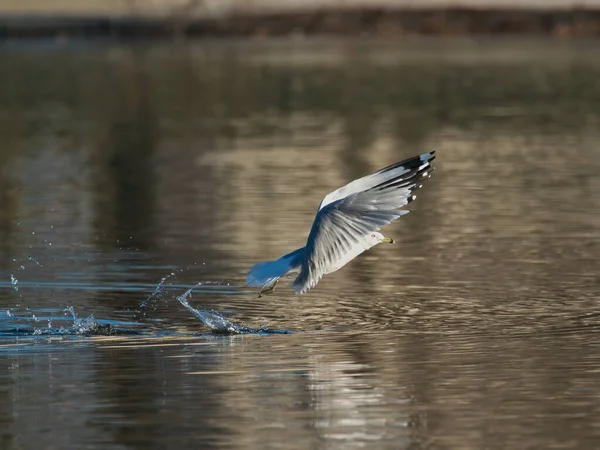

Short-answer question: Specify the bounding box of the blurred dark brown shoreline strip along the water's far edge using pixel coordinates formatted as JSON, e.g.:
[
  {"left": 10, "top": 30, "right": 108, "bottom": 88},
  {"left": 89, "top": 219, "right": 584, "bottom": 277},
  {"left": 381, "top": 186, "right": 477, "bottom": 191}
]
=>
[{"left": 0, "top": 1, "right": 600, "bottom": 41}]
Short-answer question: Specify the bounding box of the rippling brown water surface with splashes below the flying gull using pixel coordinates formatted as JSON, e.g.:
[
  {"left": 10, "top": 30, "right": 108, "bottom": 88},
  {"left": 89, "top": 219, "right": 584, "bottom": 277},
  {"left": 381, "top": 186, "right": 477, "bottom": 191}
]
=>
[{"left": 0, "top": 40, "right": 600, "bottom": 450}]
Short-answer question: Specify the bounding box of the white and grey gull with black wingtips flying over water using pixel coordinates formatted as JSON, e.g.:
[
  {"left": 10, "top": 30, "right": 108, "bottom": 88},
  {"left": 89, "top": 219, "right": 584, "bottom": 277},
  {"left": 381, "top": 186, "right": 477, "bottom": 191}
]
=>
[{"left": 247, "top": 151, "right": 435, "bottom": 298}]
